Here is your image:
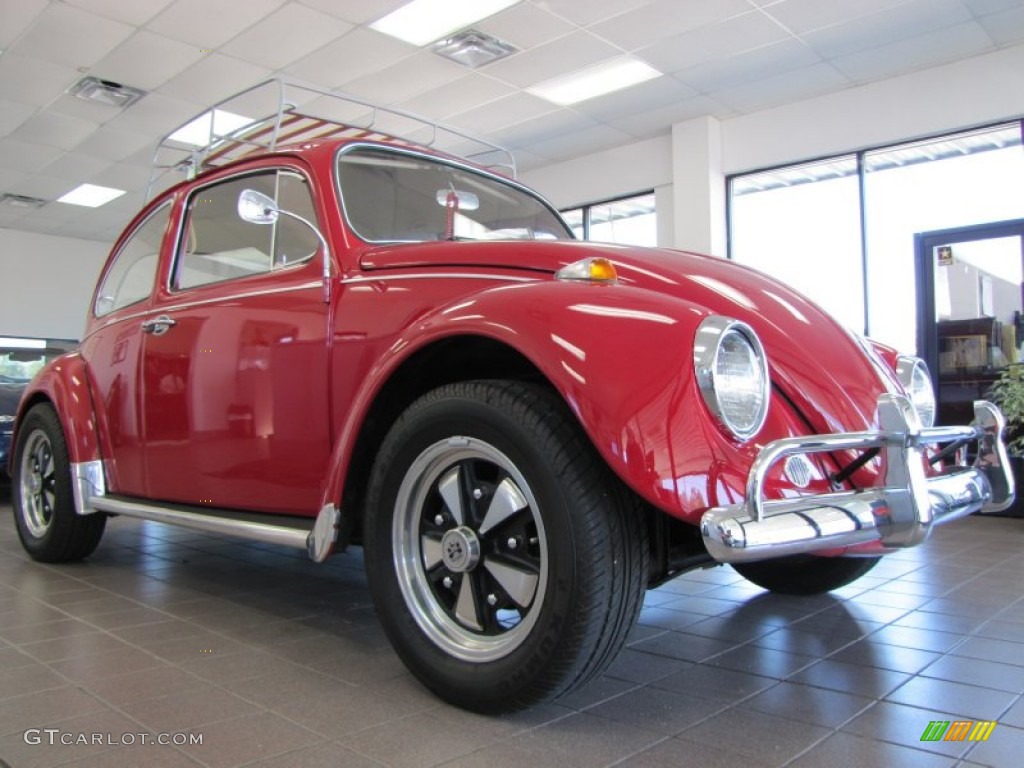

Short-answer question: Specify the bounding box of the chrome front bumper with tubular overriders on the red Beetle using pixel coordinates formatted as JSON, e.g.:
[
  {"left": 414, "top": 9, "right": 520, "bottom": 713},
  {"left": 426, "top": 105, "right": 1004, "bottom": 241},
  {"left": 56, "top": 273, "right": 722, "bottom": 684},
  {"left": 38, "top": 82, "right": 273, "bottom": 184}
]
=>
[{"left": 700, "top": 394, "right": 1014, "bottom": 562}]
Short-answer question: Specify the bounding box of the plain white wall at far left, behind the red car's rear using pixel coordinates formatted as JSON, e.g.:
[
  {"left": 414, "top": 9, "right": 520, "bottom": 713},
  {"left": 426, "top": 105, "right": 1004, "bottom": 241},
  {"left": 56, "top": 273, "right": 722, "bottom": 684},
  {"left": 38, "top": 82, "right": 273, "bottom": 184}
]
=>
[{"left": 0, "top": 228, "right": 110, "bottom": 339}]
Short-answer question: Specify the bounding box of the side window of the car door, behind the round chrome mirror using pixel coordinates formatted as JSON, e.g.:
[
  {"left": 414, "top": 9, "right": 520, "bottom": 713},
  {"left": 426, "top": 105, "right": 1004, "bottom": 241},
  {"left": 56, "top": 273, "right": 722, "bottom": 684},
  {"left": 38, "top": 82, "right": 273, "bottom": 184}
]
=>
[{"left": 174, "top": 171, "right": 319, "bottom": 290}]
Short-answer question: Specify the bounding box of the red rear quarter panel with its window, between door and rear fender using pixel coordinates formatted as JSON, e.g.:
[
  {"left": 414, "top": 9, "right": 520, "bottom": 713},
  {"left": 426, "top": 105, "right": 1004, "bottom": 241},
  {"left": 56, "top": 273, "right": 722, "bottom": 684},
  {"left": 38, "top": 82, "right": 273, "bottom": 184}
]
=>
[{"left": 81, "top": 200, "right": 172, "bottom": 496}]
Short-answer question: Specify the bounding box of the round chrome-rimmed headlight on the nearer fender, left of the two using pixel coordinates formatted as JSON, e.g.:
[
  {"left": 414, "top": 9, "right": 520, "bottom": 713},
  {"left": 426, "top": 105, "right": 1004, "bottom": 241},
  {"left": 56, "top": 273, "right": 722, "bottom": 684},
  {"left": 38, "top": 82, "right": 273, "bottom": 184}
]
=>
[{"left": 693, "top": 315, "right": 770, "bottom": 440}]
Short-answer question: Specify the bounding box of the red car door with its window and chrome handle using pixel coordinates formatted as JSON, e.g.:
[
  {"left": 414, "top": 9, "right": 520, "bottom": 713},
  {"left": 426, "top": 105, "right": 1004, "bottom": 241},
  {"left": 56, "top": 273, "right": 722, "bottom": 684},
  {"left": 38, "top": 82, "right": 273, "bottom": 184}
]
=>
[{"left": 141, "top": 168, "right": 330, "bottom": 515}]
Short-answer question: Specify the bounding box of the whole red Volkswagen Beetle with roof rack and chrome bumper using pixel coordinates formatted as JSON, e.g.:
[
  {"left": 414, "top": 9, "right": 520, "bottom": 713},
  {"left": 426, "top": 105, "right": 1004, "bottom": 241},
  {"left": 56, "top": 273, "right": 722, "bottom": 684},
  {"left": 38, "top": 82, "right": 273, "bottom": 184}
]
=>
[{"left": 10, "top": 82, "right": 1014, "bottom": 712}]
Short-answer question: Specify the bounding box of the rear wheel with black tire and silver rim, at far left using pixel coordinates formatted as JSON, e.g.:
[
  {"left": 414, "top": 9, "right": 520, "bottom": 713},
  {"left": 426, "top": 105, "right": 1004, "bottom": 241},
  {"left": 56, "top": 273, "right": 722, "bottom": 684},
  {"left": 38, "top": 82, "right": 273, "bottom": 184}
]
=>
[{"left": 11, "top": 403, "right": 106, "bottom": 562}]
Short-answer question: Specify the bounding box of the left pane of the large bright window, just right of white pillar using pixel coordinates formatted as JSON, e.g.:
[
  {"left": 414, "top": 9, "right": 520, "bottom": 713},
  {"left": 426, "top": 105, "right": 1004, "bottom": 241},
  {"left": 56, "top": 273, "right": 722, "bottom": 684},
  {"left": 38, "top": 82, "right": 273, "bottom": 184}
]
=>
[{"left": 731, "top": 156, "right": 864, "bottom": 332}]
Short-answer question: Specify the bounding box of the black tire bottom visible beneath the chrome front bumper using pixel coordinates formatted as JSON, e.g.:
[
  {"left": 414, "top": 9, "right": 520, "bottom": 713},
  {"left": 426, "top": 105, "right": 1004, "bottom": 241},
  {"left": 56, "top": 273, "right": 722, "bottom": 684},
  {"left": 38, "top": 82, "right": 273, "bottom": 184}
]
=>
[{"left": 732, "top": 555, "right": 882, "bottom": 595}]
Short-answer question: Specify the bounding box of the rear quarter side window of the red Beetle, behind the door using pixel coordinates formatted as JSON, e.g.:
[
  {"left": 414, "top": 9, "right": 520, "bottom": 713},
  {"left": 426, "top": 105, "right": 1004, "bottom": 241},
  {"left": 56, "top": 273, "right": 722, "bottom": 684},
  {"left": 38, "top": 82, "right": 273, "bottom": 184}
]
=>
[{"left": 93, "top": 203, "right": 171, "bottom": 317}]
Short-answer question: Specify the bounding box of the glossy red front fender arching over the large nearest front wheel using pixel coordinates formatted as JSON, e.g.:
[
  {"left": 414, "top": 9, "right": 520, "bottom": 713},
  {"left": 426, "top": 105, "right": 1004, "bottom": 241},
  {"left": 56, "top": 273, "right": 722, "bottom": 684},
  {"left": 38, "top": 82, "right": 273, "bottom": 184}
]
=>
[{"left": 324, "top": 282, "right": 756, "bottom": 522}]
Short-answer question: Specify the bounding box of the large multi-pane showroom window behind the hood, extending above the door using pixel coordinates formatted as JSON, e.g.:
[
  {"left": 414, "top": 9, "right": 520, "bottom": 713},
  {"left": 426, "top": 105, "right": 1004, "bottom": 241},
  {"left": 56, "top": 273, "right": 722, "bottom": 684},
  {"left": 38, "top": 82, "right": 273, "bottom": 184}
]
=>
[{"left": 729, "top": 123, "right": 1024, "bottom": 352}]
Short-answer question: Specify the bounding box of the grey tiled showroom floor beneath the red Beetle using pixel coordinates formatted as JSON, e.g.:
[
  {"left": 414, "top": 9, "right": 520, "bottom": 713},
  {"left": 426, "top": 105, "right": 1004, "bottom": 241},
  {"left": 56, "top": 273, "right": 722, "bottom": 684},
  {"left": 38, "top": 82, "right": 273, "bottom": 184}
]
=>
[{"left": 0, "top": 489, "right": 1024, "bottom": 768}]
